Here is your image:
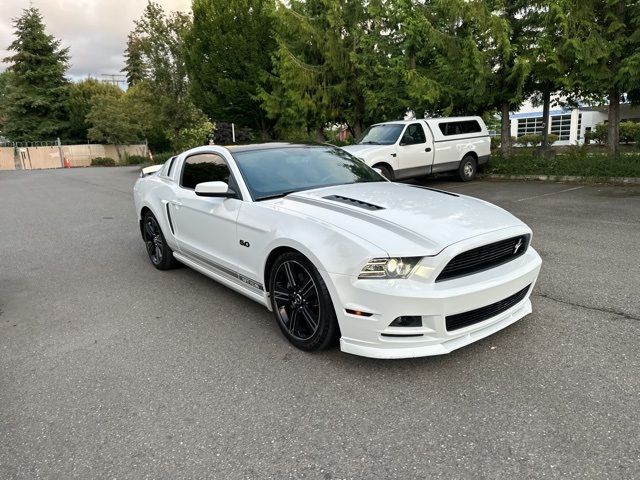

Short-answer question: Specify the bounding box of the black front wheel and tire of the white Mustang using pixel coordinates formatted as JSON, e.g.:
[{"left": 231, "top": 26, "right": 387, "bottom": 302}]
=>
[{"left": 269, "top": 252, "right": 338, "bottom": 350}]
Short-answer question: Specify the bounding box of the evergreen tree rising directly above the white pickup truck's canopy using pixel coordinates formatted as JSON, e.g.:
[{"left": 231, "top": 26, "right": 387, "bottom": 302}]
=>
[{"left": 395, "top": 0, "right": 500, "bottom": 117}]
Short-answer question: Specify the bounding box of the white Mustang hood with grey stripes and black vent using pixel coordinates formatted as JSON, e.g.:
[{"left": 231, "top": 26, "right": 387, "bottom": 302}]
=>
[{"left": 277, "top": 182, "right": 528, "bottom": 256}]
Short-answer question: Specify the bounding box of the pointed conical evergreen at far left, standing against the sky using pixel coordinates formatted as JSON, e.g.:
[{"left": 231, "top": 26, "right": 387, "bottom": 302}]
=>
[{"left": 3, "top": 7, "right": 69, "bottom": 141}]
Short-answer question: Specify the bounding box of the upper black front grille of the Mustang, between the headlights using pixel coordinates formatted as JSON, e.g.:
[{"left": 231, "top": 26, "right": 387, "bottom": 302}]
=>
[{"left": 436, "top": 235, "right": 529, "bottom": 282}]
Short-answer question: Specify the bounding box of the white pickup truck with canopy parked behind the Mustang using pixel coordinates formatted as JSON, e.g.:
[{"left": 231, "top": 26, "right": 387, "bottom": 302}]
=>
[{"left": 343, "top": 117, "right": 491, "bottom": 182}]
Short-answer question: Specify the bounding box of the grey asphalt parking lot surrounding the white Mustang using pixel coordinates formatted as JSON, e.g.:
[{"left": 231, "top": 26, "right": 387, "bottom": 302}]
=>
[{"left": 0, "top": 167, "right": 640, "bottom": 479}]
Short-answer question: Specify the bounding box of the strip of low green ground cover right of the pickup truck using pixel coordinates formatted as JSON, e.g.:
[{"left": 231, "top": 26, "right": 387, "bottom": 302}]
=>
[{"left": 485, "top": 147, "right": 640, "bottom": 177}]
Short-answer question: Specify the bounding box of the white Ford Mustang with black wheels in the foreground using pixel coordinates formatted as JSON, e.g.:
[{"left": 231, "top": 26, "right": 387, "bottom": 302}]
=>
[{"left": 134, "top": 144, "right": 541, "bottom": 358}]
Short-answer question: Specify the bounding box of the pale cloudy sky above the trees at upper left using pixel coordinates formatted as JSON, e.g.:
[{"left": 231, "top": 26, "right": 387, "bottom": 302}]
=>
[{"left": 0, "top": 0, "right": 191, "bottom": 80}]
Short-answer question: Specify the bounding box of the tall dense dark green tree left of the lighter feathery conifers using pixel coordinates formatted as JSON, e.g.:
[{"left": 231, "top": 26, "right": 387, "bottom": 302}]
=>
[{"left": 185, "top": 0, "right": 276, "bottom": 136}]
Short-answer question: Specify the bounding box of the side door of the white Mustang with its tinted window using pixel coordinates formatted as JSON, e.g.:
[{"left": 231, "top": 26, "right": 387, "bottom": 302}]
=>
[{"left": 170, "top": 152, "right": 243, "bottom": 276}]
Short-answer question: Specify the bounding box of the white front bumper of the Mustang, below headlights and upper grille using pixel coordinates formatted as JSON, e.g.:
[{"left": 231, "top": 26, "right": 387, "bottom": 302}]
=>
[{"left": 329, "top": 247, "right": 542, "bottom": 358}]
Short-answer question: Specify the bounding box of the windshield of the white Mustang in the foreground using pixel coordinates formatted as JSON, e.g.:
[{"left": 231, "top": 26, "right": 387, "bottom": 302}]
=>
[{"left": 233, "top": 146, "right": 386, "bottom": 200}]
